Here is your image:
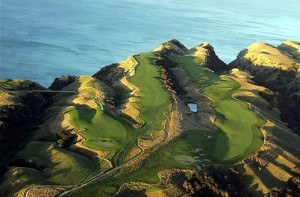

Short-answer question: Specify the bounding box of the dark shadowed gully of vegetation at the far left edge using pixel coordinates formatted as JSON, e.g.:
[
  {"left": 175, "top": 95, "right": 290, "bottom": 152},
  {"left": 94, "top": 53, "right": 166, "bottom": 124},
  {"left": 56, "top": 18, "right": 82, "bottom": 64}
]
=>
[{"left": 0, "top": 93, "right": 51, "bottom": 175}]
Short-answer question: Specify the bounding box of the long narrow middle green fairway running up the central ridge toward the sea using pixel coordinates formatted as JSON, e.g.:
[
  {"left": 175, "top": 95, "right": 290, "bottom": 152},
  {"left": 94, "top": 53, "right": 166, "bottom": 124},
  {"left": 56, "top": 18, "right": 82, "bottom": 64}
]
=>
[{"left": 128, "top": 53, "right": 172, "bottom": 137}]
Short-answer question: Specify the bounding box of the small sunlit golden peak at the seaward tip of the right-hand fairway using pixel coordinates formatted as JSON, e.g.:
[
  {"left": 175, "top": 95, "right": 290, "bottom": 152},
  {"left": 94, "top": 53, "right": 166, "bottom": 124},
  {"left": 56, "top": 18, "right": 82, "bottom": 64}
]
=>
[{"left": 189, "top": 42, "right": 228, "bottom": 72}]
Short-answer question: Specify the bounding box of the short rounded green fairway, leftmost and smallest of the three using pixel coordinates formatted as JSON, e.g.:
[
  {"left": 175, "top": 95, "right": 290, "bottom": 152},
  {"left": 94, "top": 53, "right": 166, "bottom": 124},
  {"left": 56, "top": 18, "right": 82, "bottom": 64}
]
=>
[{"left": 67, "top": 107, "right": 130, "bottom": 150}]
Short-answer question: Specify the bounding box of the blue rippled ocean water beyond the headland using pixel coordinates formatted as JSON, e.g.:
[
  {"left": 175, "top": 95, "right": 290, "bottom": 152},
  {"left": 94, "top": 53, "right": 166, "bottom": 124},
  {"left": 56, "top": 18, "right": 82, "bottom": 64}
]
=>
[{"left": 0, "top": 0, "right": 300, "bottom": 86}]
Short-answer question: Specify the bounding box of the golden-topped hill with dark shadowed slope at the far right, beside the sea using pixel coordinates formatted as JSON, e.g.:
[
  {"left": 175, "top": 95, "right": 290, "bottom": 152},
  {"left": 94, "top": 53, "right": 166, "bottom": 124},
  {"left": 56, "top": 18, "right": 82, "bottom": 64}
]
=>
[{"left": 229, "top": 41, "right": 300, "bottom": 133}]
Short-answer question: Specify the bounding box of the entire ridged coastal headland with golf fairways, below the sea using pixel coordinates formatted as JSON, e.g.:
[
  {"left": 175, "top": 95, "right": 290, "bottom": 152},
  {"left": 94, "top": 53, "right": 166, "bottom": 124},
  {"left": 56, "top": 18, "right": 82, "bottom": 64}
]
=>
[{"left": 0, "top": 40, "right": 300, "bottom": 197}]
